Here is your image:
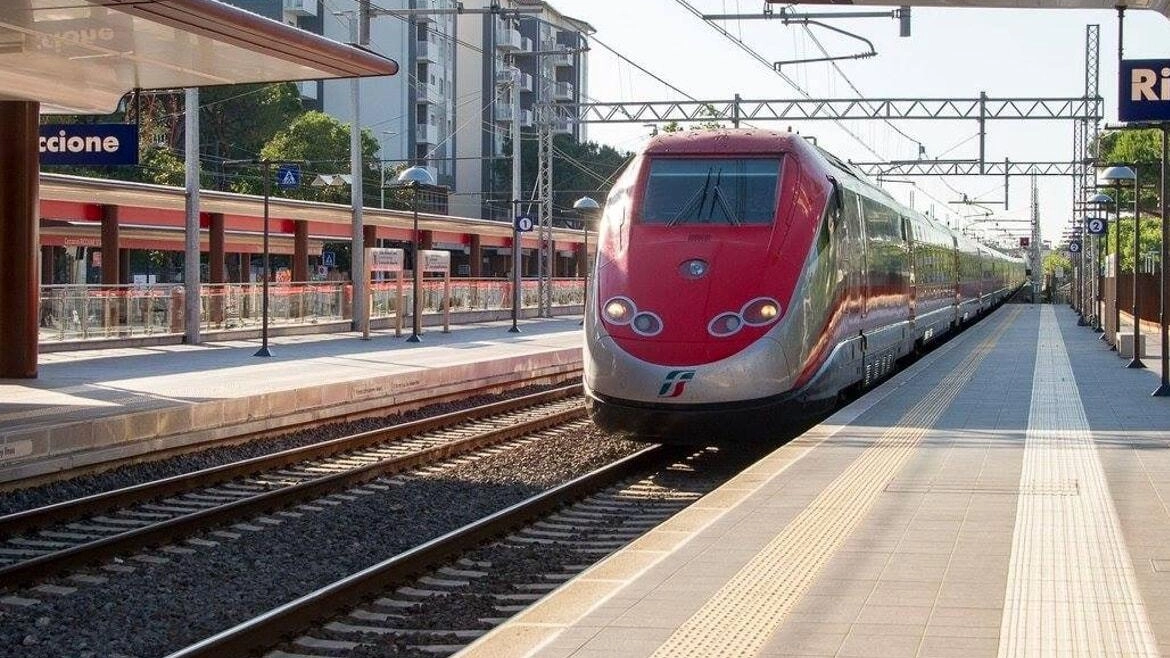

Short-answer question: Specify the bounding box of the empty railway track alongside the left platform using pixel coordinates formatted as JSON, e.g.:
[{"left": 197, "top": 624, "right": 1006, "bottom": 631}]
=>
[{"left": 0, "top": 385, "right": 584, "bottom": 589}]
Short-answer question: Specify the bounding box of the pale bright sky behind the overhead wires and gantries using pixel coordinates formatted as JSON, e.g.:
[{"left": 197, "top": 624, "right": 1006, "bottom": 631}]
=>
[{"left": 542, "top": 0, "right": 1170, "bottom": 244}]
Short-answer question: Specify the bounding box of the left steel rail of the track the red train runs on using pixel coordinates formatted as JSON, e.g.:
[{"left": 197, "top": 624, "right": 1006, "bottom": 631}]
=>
[{"left": 166, "top": 445, "right": 665, "bottom": 658}]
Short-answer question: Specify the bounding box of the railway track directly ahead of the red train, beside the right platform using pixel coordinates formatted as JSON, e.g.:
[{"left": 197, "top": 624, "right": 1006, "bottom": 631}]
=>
[{"left": 167, "top": 446, "right": 728, "bottom": 658}]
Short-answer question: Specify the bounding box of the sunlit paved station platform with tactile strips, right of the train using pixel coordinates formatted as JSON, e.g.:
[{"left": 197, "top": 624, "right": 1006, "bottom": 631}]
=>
[{"left": 456, "top": 304, "right": 1170, "bottom": 658}]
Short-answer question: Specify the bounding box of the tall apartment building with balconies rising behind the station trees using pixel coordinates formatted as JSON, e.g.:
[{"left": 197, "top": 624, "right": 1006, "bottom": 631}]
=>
[{"left": 228, "top": 0, "right": 593, "bottom": 220}]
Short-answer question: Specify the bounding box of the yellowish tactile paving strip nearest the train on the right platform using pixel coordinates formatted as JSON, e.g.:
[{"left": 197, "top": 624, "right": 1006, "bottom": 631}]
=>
[{"left": 654, "top": 309, "right": 1020, "bottom": 658}]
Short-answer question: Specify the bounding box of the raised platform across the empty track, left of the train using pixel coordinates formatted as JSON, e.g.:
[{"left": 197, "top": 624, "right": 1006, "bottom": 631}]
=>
[{"left": 0, "top": 316, "right": 581, "bottom": 485}]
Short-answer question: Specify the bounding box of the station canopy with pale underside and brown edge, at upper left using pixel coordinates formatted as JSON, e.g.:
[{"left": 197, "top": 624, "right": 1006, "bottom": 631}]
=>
[{"left": 0, "top": 0, "right": 398, "bottom": 114}]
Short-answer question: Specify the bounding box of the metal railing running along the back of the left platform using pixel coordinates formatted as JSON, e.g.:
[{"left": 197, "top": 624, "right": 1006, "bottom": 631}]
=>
[{"left": 39, "top": 277, "right": 584, "bottom": 343}]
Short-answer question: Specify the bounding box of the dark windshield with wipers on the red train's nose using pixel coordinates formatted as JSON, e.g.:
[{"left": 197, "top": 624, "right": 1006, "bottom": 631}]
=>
[{"left": 642, "top": 158, "right": 780, "bottom": 226}]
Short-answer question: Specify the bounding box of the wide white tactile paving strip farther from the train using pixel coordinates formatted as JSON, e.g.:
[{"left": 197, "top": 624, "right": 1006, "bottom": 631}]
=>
[{"left": 999, "top": 307, "right": 1158, "bottom": 658}]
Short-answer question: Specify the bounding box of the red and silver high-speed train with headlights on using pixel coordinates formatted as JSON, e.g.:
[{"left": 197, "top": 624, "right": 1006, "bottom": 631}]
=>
[{"left": 585, "top": 130, "right": 1025, "bottom": 443}]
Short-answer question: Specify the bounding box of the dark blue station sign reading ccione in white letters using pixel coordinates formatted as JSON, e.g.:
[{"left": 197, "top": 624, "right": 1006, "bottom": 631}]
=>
[{"left": 40, "top": 123, "right": 138, "bottom": 165}]
